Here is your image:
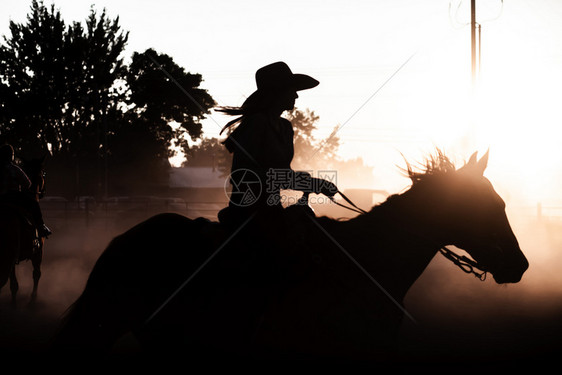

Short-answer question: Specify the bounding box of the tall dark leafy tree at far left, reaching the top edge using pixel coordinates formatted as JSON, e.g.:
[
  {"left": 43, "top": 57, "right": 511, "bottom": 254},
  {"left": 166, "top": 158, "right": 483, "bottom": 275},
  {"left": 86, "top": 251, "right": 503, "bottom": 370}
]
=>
[{"left": 0, "top": 0, "right": 127, "bottom": 157}]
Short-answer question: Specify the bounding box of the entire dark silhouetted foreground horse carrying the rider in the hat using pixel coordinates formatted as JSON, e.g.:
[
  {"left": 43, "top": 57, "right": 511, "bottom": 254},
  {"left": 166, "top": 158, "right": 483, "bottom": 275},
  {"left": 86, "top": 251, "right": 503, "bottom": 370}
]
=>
[{"left": 51, "top": 151, "right": 528, "bottom": 358}]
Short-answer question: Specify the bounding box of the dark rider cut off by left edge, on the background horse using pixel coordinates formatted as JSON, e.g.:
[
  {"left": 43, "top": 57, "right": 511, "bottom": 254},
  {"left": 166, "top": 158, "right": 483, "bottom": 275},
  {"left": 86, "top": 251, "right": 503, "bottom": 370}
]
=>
[{"left": 0, "top": 144, "right": 52, "bottom": 237}]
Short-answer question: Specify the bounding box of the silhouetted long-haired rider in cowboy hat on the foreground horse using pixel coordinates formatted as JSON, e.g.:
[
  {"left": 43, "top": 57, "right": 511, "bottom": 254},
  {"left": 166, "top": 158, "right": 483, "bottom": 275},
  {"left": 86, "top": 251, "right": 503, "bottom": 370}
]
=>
[{"left": 218, "top": 62, "right": 338, "bottom": 288}]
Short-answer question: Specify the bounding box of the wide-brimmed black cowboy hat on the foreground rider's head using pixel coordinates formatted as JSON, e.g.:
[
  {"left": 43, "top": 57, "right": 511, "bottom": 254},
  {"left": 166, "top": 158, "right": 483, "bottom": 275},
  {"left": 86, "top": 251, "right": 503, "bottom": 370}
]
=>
[{"left": 256, "top": 61, "right": 320, "bottom": 91}]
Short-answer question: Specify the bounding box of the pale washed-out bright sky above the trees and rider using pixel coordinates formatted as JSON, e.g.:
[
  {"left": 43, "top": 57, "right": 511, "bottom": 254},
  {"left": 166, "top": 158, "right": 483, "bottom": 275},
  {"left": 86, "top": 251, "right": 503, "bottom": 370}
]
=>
[{"left": 0, "top": 0, "right": 562, "bottom": 206}]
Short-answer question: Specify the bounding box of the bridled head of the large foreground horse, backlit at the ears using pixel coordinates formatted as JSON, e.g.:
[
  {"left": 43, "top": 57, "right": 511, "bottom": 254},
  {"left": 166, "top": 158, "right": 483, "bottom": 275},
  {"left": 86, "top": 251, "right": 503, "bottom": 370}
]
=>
[{"left": 409, "top": 152, "right": 529, "bottom": 284}]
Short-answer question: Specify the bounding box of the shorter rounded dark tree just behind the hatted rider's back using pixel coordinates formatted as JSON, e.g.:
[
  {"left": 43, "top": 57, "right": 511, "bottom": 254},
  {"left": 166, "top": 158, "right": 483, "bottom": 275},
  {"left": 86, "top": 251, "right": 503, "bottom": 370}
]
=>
[{"left": 109, "top": 49, "right": 215, "bottom": 194}]
